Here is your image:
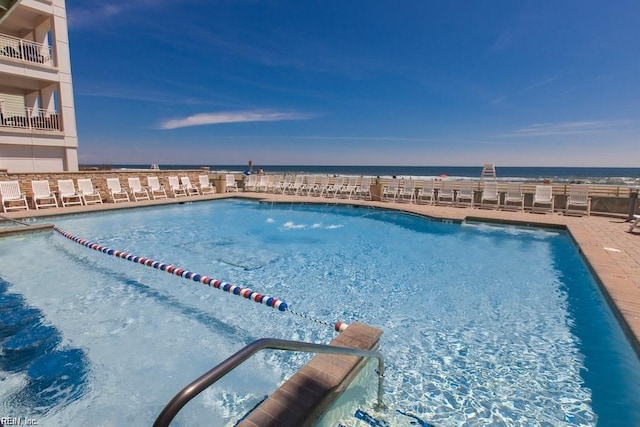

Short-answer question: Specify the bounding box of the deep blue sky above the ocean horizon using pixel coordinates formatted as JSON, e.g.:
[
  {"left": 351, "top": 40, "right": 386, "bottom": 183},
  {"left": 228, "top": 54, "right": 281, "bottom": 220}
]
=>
[{"left": 67, "top": 0, "right": 640, "bottom": 167}]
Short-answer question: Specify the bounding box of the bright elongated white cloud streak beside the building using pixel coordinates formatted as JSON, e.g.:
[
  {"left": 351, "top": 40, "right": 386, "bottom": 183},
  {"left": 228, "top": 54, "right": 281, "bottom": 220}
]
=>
[{"left": 159, "top": 111, "right": 314, "bottom": 129}]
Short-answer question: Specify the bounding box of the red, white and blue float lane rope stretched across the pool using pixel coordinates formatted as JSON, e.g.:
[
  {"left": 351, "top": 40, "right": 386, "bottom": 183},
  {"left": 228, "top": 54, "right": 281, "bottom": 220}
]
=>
[{"left": 53, "top": 226, "right": 349, "bottom": 332}]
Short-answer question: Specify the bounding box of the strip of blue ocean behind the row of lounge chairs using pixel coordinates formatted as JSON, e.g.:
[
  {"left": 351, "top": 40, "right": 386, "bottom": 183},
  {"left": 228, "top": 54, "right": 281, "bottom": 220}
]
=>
[{"left": 106, "top": 164, "right": 640, "bottom": 187}]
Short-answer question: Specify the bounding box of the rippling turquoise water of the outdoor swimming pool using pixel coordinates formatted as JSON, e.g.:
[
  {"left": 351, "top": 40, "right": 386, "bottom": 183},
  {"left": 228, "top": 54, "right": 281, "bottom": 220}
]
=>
[{"left": 0, "top": 201, "right": 640, "bottom": 426}]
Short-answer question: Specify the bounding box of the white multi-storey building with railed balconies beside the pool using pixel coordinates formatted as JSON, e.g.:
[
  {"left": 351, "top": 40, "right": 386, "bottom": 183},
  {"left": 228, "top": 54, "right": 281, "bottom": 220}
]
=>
[{"left": 0, "top": 0, "right": 78, "bottom": 173}]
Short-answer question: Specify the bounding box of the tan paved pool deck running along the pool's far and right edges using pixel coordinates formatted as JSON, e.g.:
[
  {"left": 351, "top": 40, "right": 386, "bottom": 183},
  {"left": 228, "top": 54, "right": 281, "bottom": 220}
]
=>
[{"left": 0, "top": 192, "right": 640, "bottom": 425}]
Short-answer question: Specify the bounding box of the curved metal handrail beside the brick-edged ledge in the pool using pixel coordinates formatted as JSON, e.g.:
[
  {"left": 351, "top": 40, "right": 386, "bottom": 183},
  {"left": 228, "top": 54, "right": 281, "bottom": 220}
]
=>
[{"left": 153, "top": 338, "right": 384, "bottom": 427}]
